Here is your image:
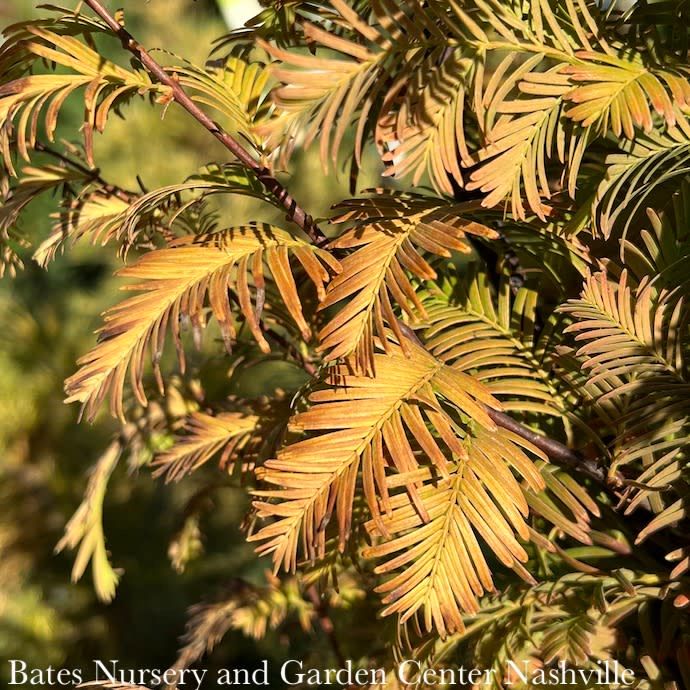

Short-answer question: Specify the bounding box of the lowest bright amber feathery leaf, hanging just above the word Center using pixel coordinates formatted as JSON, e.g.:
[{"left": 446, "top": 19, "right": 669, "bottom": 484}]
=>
[{"left": 364, "top": 428, "right": 544, "bottom": 638}]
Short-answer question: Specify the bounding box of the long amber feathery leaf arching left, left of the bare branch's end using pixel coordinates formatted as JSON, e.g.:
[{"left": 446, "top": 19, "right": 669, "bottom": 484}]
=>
[{"left": 65, "top": 225, "right": 338, "bottom": 418}]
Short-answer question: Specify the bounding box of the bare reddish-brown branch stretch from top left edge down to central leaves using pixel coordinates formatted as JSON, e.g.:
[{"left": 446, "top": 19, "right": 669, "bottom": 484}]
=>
[{"left": 84, "top": 0, "right": 327, "bottom": 246}]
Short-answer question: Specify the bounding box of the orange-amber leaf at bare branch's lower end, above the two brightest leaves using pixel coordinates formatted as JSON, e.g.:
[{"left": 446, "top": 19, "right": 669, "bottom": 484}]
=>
[{"left": 319, "top": 194, "right": 498, "bottom": 373}]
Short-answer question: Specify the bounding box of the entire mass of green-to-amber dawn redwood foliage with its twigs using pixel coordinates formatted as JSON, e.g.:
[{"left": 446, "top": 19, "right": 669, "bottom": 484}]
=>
[{"left": 0, "top": 0, "right": 690, "bottom": 689}]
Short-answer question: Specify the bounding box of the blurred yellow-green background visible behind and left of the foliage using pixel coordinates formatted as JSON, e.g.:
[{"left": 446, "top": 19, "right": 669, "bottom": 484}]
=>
[{"left": 0, "top": 0, "right": 382, "bottom": 685}]
